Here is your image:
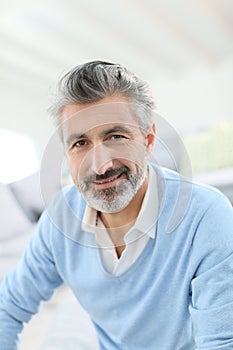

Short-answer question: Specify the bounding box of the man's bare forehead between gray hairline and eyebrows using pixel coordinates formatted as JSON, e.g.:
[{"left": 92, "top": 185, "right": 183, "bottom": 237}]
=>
[{"left": 61, "top": 101, "right": 139, "bottom": 138}]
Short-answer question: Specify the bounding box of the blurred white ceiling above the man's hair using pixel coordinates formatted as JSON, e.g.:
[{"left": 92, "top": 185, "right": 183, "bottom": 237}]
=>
[{"left": 0, "top": 0, "right": 233, "bottom": 93}]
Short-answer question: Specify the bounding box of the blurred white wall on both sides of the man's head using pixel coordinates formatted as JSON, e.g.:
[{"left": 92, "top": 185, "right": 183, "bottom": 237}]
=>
[{"left": 0, "top": 59, "right": 233, "bottom": 161}]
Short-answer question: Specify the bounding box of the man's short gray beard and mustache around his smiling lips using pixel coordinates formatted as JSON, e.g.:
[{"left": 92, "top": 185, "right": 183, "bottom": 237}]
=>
[{"left": 78, "top": 165, "right": 147, "bottom": 213}]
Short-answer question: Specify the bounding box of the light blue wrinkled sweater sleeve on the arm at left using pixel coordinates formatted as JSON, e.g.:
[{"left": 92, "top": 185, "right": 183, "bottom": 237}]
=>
[{"left": 0, "top": 213, "right": 62, "bottom": 350}]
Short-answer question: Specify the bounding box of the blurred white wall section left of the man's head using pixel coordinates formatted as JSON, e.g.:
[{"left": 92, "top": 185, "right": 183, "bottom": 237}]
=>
[{"left": 0, "top": 81, "right": 54, "bottom": 155}]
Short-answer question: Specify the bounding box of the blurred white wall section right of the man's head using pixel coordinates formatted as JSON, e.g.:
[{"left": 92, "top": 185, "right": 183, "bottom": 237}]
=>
[{"left": 153, "top": 58, "right": 233, "bottom": 132}]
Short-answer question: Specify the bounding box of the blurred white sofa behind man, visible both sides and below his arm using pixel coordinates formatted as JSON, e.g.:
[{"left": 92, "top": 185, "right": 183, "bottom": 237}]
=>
[{"left": 0, "top": 163, "right": 233, "bottom": 350}]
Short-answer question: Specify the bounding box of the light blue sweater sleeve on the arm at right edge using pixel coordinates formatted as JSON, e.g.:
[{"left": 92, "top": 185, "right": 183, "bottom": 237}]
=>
[{"left": 190, "top": 195, "right": 233, "bottom": 350}]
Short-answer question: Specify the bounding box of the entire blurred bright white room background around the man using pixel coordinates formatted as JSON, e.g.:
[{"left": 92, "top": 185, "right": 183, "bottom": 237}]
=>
[{"left": 0, "top": 0, "right": 233, "bottom": 350}]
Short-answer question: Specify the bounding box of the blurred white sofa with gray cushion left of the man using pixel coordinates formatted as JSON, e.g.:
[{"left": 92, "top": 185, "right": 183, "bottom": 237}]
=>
[{"left": 0, "top": 171, "right": 59, "bottom": 281}]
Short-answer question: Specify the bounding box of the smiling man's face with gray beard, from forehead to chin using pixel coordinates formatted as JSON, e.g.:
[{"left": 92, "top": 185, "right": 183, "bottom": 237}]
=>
[{"left": 62, "top": 97, "right": 154, "bottom": 212}]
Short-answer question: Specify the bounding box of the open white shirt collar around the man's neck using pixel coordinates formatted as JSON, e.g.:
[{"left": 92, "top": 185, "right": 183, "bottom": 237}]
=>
[{"left": 82, "top": 165, "right": 158, "bottom": 241}]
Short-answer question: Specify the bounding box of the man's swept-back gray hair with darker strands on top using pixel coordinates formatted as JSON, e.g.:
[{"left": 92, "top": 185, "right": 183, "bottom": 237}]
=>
[{"left": 49, "top": 61, "right": 155, "bottom": 130}]
